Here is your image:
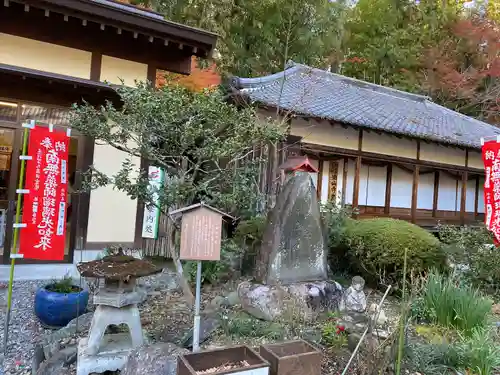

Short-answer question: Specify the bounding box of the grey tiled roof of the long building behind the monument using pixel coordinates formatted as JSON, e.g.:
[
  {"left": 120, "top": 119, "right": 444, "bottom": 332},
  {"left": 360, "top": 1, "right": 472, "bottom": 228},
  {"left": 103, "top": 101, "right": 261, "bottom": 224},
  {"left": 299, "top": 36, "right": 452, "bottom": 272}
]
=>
[{"left": 234, "top": 62, "right": 500, "bottom": 148}]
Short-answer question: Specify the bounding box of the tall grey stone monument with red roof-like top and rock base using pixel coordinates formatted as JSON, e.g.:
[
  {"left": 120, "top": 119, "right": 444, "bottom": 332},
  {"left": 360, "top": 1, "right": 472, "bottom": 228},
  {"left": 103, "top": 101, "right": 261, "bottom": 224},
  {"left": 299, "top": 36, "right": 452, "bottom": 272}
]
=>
[{"left": 238, "top": 156, "right": 342, "bottom": 320}]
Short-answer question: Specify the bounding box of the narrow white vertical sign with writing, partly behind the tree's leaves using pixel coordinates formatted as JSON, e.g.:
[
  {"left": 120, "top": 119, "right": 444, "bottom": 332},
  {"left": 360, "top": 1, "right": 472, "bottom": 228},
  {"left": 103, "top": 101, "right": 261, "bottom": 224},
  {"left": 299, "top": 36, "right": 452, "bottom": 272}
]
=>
[{"left": 142, "top": 166, "right": 164, "bottom": 239}]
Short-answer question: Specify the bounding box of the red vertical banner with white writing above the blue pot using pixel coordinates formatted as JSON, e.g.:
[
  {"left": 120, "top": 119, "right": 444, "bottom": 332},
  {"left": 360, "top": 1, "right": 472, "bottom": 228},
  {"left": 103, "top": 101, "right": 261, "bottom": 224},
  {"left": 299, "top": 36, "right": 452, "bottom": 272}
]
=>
[{"left": 19, "top": 126, "right": 69, "bottom": 260}]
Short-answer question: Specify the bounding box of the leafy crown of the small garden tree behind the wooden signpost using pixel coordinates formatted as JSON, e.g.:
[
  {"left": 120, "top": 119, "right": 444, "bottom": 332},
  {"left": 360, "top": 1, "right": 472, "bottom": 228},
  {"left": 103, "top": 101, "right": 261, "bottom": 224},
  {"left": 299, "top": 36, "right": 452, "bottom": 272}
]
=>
[{"left": 72, "top": 83, "right": 283, "bottom": 217}]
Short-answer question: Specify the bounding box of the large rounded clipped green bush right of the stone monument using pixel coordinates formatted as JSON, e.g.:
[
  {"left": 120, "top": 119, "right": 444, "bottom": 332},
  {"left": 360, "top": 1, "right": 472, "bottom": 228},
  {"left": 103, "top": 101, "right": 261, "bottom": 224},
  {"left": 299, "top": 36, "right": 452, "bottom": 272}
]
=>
[{"left": 343, "top": 218, "right": 445, "bottom": 286}]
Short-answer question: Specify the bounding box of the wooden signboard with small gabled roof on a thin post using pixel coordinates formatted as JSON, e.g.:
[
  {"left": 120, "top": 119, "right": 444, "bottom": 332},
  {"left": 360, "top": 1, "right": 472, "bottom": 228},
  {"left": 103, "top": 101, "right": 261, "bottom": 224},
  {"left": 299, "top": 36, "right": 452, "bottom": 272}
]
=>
[{"left": 170, "top": 202, "right": 234, "bottom": 352}]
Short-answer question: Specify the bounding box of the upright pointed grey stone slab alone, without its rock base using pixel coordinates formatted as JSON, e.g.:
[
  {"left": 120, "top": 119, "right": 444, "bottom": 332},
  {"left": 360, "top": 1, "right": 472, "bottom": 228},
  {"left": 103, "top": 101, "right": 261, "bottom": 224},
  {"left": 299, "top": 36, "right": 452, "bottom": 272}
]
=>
[{"left": 257, "top": 172, "right": 328, "bottom": 285}]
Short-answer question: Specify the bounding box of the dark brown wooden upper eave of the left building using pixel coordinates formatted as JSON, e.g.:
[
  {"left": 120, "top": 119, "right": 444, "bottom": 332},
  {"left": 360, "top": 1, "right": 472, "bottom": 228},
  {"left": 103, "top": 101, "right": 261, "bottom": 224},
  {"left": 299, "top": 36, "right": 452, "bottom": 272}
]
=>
[{"left": 0, "top": 0, "right": 217, "bottom": 73}]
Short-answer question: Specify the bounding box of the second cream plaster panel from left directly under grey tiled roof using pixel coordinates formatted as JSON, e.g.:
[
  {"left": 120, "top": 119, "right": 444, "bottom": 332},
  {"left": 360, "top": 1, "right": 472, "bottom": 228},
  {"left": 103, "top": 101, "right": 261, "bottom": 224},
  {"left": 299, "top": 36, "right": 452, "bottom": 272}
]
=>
[{"left": 362, "top": 131, "right": 417, "bottom": 159}]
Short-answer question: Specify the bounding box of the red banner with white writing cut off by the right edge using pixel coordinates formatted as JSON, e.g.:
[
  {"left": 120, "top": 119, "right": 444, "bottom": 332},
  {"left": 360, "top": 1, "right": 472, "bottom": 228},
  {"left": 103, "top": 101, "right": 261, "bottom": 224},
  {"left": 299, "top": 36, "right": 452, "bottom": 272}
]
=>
[{"left": 482, "top": 141, "right": 500, "bottom": 244}]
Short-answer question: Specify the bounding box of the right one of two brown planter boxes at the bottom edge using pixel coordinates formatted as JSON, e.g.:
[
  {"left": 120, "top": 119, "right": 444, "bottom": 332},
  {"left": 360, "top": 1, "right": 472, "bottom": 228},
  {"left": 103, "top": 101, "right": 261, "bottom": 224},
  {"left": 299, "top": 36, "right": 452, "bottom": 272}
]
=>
[{"left": 260, "top": 340, "right": 321, "bottom": 375}]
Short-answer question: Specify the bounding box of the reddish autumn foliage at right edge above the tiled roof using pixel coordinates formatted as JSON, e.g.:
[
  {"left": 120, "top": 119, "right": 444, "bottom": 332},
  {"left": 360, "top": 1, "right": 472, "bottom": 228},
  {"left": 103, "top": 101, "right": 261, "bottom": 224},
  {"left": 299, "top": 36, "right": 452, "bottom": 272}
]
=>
[{"left": 422, "top": 17, "right": 500, "bottom": 123}]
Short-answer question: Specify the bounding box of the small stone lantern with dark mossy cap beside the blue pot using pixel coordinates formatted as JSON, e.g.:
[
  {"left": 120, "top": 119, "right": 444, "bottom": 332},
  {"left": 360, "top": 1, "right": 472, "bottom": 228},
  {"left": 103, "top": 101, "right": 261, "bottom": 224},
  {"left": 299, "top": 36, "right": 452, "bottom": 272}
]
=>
[{"left": 77, "top": 253, "right": 161, "bottom": 375}]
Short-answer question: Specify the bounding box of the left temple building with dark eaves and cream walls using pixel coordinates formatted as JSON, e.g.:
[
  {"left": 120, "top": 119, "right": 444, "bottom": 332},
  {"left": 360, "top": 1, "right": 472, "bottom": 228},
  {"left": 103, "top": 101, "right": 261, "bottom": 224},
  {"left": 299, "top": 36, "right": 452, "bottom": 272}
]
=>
[{"left": 0, "top": 0, "right": 217, "bottom": 279}]
